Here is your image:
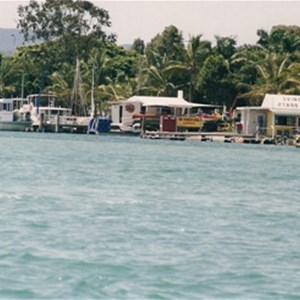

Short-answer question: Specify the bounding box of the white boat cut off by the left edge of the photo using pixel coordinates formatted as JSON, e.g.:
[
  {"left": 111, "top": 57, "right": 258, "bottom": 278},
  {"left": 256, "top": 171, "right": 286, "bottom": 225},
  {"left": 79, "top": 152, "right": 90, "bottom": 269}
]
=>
[{"left": 0, "top": 98, "right": 32, "bottom": 131}]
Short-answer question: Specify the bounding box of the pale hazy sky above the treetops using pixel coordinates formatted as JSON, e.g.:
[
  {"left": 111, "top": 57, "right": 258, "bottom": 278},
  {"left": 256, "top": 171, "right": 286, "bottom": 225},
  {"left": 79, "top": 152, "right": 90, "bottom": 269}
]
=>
[{"left": 0, "top": 0, "right": 300, "bottom": 45}]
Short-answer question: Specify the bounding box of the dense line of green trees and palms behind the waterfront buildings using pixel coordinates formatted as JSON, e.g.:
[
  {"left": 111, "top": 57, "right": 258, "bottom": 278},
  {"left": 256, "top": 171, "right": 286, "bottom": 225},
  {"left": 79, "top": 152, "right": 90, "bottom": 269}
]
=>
[{"left": 0, "top": 0, "right": 300, "bottom": 112}]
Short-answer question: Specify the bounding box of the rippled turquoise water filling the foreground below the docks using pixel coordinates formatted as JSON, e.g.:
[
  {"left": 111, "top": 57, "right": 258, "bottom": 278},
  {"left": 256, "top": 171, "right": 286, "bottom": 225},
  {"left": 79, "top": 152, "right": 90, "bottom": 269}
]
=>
[{"left": 0, "top": 132, "right": 300, "bottom": 299}]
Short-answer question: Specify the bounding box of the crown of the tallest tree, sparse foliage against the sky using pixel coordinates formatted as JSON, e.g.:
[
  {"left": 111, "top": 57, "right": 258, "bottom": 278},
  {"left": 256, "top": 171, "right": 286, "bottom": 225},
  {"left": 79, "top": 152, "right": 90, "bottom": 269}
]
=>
[{"left": 18, "top": 0, "right": 114, "bottom": 61}]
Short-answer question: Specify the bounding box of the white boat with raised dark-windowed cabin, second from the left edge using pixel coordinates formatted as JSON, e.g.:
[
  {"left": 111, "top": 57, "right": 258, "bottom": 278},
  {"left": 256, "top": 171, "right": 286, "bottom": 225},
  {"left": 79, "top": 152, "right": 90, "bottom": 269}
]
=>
[{"left": 24, "top": 94, "right": 87, "bottom": 133}]
